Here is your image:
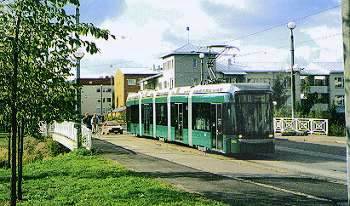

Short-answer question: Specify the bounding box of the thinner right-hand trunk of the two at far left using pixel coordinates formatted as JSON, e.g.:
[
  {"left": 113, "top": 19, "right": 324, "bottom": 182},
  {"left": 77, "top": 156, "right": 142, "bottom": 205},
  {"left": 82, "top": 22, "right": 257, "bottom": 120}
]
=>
[{"left": 17, "top": 118, "right": 24, "bottom": 200}]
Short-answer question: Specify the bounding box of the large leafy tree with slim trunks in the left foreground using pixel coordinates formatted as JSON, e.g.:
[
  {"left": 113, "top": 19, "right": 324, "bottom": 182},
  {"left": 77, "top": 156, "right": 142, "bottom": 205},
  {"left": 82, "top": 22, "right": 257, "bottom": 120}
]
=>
[{"left": 0, "top": 0, "right": 115, "bottom": 205}]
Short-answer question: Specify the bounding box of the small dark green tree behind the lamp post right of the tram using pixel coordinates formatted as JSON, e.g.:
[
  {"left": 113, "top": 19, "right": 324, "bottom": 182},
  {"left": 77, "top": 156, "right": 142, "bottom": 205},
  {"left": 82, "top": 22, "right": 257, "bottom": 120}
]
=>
[{"left": 272, "top": 74, "right": 289, "bottom": 110}]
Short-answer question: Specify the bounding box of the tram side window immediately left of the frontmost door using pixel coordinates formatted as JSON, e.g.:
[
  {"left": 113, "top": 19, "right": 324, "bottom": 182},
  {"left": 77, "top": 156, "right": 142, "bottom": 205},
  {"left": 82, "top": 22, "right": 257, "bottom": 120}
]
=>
[{"left": 192, "top": 103, "right": 210, "bottom": 131}]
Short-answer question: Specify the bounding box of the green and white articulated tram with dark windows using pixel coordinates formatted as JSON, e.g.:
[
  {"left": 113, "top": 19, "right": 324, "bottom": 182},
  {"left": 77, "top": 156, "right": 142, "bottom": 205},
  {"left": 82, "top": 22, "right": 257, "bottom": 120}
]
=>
[{"left": 126, "top": 83, "right": 274, "bottom": 154}]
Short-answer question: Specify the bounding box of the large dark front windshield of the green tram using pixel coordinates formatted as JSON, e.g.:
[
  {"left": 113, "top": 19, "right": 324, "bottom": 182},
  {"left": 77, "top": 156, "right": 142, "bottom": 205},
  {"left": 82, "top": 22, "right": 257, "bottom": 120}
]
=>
[{"left": 235, "top": 93, "right": 273, "bottom": 139}]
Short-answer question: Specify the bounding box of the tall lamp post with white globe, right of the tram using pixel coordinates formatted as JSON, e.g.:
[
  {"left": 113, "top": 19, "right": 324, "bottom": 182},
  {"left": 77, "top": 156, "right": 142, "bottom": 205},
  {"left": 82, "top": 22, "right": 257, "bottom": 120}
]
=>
[{"left": 287, "top": 22, "right": 296, "bottom": 119}]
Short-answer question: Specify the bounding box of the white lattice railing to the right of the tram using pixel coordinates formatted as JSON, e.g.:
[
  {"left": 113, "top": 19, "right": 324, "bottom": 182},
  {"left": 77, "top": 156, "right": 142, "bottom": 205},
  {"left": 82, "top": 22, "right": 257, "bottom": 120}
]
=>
[{"left": 273, "top": 118, "right": 328, "bottom": 135}]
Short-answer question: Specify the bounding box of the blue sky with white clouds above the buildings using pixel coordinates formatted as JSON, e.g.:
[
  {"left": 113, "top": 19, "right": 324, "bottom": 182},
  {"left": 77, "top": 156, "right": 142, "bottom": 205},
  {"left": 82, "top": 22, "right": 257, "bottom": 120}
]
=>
[{"left": 76, "top": 0, "right": 342, "bottom": 77}]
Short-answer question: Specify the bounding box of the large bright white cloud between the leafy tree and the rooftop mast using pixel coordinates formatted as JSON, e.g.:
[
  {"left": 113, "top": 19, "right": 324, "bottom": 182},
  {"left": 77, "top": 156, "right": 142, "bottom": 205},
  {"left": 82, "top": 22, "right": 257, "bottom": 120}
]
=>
[{"left": 82, "top": 0, "right": 230, "bottom": 75}]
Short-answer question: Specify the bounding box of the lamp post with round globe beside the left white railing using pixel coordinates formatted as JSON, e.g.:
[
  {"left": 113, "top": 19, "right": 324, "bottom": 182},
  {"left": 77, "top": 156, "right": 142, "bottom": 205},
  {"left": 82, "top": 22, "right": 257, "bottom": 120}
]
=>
[{"left": 74, "top": 49, "right": 85, "bottom": 147}]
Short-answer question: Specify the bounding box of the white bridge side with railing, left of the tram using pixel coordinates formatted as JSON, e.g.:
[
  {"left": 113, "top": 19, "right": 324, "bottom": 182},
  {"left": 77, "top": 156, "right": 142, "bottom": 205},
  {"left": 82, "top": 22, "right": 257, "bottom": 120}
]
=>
[{"left": 39, "top": 121, "right": 92, "bottom": 150}]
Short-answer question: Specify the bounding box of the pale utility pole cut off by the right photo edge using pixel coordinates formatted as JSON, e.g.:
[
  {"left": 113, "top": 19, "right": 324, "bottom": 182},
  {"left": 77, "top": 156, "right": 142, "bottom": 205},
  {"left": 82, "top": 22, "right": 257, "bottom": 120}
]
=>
[{"left": 342, "top": 0, "right": 350, "bottom": 205}]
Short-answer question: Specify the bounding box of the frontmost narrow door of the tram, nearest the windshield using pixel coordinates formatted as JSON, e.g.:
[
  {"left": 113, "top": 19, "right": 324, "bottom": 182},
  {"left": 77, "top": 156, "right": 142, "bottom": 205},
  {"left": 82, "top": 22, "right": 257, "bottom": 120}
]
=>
[{"left": 210, "top": 104, "right": 223, "bottom": 150}]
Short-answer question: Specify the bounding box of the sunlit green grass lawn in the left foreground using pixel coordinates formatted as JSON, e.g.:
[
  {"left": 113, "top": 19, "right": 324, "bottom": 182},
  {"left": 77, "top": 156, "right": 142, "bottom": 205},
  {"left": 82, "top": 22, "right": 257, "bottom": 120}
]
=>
[{"left": 0, "top": 153, "right": 221, "bottom": 206}]
